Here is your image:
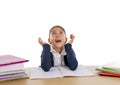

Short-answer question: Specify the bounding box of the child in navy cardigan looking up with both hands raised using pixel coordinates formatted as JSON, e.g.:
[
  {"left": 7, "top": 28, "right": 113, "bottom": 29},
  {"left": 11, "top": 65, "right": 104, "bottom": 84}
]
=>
[{"left": 38, "top": 26, "right": 78, "bottom": 71}]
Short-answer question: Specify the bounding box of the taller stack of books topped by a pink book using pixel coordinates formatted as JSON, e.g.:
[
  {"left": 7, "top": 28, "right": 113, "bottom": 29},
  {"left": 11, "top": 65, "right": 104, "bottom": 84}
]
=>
[{"left": 0, "top": 55, "right": 29, "bottom": 81}]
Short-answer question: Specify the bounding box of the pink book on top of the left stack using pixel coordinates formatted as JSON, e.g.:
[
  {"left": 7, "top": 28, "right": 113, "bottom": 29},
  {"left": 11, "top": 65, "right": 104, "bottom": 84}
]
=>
[{"left": 0, "top": 55, "right": 29, "bottom": 66}]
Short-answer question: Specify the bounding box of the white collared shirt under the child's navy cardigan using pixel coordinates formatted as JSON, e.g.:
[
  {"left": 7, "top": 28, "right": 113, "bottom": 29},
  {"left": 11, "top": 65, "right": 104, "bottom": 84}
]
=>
[{"left": 50, "top": 46, "right": 66, "bottom": 66}]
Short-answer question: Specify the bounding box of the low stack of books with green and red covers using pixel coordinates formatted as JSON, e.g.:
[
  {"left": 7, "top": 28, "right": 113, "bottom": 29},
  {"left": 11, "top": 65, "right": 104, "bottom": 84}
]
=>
[{"left": 96, "top": 62, "right": 120, "bottom": 77}]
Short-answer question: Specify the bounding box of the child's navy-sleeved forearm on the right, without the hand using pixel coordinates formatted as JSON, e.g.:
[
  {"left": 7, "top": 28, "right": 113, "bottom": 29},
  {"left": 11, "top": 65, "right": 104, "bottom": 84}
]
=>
[{"left": 65, "top": 44, "right": 78, "bottom": 70}]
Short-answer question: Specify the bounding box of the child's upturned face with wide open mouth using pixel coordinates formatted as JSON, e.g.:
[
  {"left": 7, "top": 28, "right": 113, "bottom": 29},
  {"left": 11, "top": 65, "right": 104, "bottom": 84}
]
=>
[{"left": 48, "top": 27, "right": 67, "bottom": 48}]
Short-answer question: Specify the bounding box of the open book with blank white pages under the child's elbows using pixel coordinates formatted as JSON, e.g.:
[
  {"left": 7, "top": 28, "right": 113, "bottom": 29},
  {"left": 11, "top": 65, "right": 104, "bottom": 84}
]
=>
[{"left": 30, "top": 65, "right": 94, "bottom": 79}]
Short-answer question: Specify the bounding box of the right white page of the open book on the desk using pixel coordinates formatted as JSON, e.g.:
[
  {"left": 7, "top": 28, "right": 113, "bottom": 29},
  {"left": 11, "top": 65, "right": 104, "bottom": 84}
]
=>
[{"left": 59, "top": 65, "right": 94, "bottom": 76}]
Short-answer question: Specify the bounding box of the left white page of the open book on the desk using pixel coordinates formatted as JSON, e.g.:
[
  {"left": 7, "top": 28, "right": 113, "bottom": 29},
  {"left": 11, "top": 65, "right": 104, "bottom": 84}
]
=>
[{"left": 30, "top": 67, "right": 62, "bottom": 79}]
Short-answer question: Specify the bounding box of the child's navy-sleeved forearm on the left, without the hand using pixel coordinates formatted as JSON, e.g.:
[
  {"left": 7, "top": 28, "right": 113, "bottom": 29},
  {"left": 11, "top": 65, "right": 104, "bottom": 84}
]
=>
[{"left": 41, "top": 44, "right": 52, "bottom": 71}]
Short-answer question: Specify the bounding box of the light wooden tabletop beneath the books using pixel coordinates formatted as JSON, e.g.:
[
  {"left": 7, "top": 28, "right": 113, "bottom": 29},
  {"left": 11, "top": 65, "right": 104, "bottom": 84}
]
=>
[{"left": 0, "top": 66, "right": 120, "bottom": 85}]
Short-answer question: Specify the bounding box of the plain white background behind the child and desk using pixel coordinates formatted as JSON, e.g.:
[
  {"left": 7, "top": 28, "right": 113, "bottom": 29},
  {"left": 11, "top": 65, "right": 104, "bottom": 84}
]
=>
[{"left": 0, "top": 0, "right": 120, "bottom": 67}]
